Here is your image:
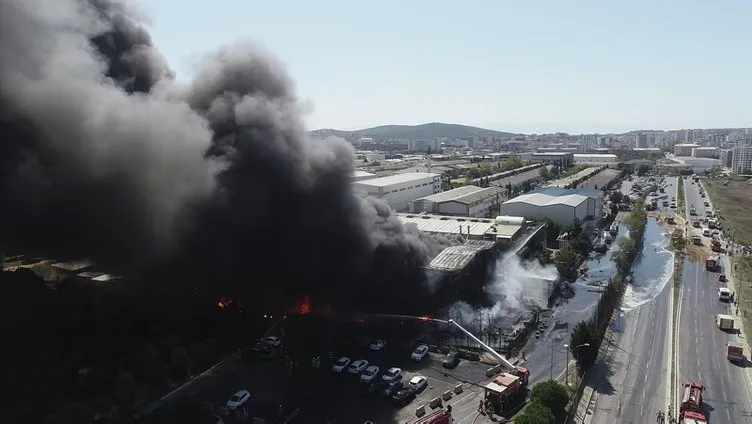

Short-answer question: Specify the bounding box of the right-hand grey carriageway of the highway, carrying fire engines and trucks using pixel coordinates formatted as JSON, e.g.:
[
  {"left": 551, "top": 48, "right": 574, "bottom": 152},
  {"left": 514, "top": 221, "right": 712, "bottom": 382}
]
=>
[{"left": 677, "top": 180, "right": 752, "bottom": 424}]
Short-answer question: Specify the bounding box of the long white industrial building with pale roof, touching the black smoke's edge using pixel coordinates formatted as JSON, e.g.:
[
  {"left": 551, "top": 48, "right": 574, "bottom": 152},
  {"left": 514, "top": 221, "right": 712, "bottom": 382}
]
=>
[{"left": 353, "top": 172, "right": 441, "bottom": 211}]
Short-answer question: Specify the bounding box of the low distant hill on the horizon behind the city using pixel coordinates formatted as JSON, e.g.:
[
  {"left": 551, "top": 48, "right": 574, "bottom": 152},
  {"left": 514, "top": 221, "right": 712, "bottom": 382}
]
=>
[{"left": 311, "top": 122, "right": 515, "bottom": 139}]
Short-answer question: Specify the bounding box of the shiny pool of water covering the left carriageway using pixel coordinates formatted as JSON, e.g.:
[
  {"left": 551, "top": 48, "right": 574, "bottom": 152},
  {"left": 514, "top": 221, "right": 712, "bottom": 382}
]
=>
[{"left": 622, "top": 218, "right": 674, "bottom": 312}]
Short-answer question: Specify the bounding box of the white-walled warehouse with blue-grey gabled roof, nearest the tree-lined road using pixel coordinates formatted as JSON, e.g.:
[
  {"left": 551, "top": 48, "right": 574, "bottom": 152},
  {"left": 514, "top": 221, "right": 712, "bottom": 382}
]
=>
[{"left": 501, "top": 188, "right": 603, "bottom": 227}]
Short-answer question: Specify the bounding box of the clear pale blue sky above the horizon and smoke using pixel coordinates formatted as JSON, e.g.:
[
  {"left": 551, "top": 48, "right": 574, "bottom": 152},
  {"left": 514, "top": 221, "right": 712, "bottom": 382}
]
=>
[{"left": 140, "top": 0, "right": 752, "bottom": 133}]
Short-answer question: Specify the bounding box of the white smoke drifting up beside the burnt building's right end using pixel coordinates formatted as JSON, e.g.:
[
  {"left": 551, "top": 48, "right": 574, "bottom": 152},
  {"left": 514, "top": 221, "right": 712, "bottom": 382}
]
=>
[{"left": 449, "top": 252, "right": 559, "bottom": 322}]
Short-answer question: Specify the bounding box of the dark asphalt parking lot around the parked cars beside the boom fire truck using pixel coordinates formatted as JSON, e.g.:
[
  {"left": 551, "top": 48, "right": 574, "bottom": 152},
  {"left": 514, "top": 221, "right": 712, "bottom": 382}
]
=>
[{"left": 170, "top": 341, "right": 500, "bottom": 424}]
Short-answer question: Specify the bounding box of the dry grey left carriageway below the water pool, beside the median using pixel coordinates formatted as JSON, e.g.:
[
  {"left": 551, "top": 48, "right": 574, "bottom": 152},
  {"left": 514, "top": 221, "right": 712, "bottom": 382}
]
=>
[{"left": 590, "top": 264, "right": 671, "bottom": 424}]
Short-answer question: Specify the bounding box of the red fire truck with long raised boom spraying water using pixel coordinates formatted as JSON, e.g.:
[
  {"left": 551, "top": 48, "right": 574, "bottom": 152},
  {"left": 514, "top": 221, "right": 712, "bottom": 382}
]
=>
[{"left": 447, "top": 319, "right": 530, "bottom": 414}]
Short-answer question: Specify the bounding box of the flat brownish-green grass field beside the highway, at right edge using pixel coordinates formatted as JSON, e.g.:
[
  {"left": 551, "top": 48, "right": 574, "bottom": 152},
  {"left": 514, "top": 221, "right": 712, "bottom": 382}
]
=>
[{"left": 703, "top": 179, "right": 752, "bottom": 246}]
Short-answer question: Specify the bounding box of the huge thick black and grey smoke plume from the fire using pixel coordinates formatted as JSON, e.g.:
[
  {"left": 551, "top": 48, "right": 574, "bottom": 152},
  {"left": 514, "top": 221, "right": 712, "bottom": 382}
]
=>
[{"left": 0, "top": 0, "right": 462, "bottom": 312}]
